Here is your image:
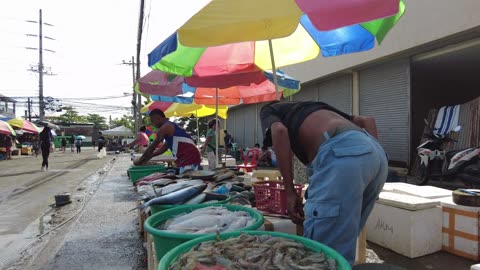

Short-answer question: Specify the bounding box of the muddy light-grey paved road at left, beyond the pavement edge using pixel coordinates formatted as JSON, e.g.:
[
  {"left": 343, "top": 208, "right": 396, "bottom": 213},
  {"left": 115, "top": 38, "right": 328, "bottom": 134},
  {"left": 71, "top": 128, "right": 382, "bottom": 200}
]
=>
[{"left": 0, "top": 148, "right": 111, "bottom": 260}]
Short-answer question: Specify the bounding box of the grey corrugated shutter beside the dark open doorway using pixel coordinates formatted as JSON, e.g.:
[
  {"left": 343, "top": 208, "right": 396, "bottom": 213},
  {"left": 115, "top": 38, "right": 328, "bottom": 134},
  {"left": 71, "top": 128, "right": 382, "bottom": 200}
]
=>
[{"left": 359, "top": 60, "right": 410, "bottom": 165}]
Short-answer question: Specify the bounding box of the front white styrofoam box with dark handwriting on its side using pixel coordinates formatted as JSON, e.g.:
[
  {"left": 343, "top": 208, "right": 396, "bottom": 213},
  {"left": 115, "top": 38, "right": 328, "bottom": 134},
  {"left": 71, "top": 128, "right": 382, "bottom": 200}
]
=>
[{"left": 365, "top": 203, "right": 442, "bottom": 258}]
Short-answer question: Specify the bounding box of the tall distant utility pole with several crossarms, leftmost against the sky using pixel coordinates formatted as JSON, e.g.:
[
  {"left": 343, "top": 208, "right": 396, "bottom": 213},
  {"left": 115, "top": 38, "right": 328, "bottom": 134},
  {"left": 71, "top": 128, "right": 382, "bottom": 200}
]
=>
[{"left": 26, "top": 9, "right": 55, "bottom": 120}]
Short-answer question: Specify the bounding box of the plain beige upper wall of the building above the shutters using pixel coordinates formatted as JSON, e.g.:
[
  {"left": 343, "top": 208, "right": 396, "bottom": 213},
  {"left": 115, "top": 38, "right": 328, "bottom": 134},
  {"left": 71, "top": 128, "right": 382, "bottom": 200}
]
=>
[{"left": 283, "top": 0, "right": 480, "bottom": 82}]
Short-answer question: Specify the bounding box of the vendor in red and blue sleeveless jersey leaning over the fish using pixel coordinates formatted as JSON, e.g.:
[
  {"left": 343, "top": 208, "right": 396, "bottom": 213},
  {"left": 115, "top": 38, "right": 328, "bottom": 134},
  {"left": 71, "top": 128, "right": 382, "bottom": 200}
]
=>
[{"left": 134, "top": 109, "right": 201, "bottom": 173}]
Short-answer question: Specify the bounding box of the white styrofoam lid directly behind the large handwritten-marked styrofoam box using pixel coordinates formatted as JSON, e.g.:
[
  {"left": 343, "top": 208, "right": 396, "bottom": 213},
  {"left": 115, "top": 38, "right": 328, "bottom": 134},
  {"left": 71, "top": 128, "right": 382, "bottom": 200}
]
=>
[{"left": 383, "top": 183, "right": 452, "bottom": 199}]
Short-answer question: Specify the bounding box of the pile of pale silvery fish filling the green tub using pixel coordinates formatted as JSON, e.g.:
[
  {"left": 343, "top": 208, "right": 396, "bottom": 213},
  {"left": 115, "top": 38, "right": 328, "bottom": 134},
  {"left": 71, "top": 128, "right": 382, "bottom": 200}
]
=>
[{"left": 160, "top": 206, "right": 255, "bottom": 233}]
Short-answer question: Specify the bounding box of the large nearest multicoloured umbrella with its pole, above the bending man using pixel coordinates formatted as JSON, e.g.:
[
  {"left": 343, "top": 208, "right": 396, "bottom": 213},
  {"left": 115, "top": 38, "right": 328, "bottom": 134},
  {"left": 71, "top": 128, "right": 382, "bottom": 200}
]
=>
[{"left": 154, "top": 0, "right": 405, "bottom": 98}]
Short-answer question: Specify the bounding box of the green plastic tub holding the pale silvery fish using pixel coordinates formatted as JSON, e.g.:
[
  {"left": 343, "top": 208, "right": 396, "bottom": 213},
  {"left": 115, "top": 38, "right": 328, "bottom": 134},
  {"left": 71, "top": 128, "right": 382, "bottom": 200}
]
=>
[{"left": 144, "top": 204, "right": 263, "bottom": 261}]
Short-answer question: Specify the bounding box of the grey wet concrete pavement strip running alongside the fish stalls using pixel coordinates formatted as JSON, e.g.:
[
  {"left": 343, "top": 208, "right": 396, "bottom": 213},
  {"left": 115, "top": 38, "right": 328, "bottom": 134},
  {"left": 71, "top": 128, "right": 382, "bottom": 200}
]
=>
[{"left": 35, "top": 154, "right": 146, "bottom": 270}]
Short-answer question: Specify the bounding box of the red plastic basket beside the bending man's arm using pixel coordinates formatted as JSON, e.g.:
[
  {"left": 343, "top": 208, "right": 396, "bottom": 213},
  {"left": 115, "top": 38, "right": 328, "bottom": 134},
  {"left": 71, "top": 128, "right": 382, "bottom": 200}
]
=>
[{"left": 253, "top": 181, "right": 303, "bottom": 215}]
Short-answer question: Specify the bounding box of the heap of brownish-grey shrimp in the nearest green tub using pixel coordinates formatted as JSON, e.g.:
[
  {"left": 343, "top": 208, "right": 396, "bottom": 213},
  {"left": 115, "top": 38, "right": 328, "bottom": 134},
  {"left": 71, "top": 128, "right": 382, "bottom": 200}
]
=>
[{"left": 169, "top": 234, "right": 337, "bottom": 270}]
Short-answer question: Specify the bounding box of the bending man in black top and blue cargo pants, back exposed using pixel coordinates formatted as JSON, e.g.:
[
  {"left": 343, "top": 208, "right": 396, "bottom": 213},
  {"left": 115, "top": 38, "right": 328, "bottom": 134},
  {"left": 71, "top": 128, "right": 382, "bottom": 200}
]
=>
[{"left": 260, "top": 101, "right": 388, "bottom": 264}]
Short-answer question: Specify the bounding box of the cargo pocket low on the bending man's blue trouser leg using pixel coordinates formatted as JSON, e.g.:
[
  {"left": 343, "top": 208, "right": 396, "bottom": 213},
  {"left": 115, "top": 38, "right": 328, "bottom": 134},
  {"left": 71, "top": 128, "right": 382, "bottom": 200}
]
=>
[{"left": 304, "top": 200, "right": 340, "bottom": 239}]
